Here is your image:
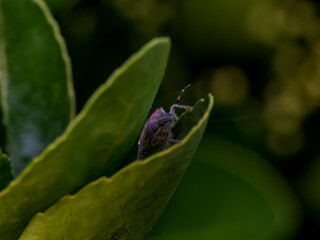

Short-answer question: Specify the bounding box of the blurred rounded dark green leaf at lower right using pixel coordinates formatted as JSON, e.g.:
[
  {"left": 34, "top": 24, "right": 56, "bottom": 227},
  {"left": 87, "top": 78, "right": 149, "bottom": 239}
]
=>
[{"left": 147, "top": 136, "right": 301, "bottom": 240}]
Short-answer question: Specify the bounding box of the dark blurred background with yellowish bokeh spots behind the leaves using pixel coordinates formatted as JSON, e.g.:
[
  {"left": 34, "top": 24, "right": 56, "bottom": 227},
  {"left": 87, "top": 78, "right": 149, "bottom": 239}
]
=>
[{"left": 47, "top": 0, "right": 320, "bottom": 239}]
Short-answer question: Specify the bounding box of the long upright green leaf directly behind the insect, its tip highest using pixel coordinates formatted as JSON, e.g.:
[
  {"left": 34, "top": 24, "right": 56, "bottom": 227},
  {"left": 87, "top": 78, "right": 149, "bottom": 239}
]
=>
[{"left": 0, "top": 38, "right": 170, "bottom": 240}]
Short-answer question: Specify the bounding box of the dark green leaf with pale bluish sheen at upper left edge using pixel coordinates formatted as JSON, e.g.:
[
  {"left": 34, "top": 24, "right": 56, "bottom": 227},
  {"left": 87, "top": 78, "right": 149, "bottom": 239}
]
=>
[{"left": 0, "top": 0, "right": 75, "bottom": 173}]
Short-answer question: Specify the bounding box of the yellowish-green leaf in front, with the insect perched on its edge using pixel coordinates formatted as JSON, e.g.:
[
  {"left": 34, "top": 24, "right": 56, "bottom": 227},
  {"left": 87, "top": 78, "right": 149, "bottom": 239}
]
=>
[{"left": 20, "top": 95, "right": 213, "bottom": 240}]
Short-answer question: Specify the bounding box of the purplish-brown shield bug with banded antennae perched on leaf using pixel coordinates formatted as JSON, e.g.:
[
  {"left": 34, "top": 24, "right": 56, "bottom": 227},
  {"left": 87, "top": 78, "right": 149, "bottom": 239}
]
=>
[{"left": 138, "top": 84, "right": 192, "bottom": 159}]
